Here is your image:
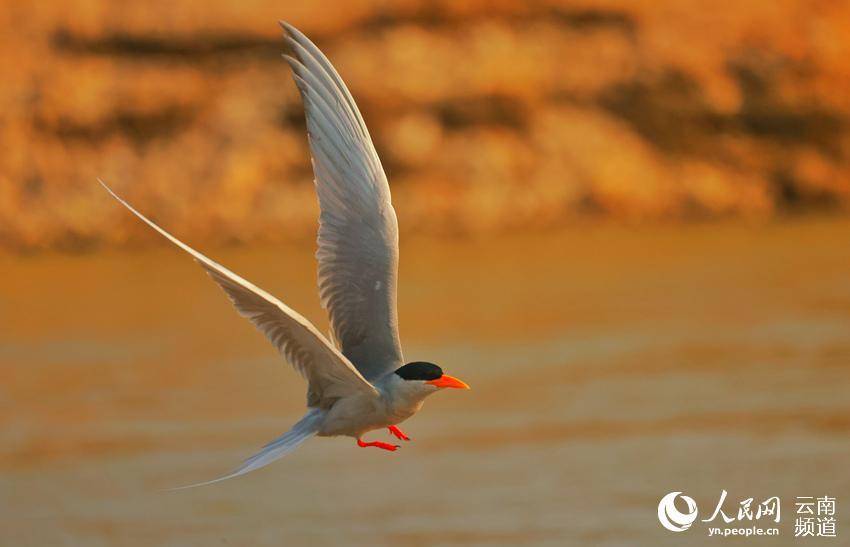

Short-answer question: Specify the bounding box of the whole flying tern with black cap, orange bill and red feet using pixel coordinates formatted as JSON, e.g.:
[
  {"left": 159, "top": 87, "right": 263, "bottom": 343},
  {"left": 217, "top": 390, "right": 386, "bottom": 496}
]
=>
[{"left": 100, "top": 22, "right": 469, "bottom": 488}]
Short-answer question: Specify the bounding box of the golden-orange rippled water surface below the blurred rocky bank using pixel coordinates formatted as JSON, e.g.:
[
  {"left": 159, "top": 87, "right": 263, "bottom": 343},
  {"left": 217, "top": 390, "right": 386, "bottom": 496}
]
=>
[{"left": 0, "top": 220, "right": 850, "bottom": 546}]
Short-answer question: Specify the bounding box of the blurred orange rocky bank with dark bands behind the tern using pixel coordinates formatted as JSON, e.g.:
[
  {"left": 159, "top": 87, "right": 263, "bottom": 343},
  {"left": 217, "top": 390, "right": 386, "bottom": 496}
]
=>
[{"left": 0, "top": 0, "right": 850, "bottom": 251}]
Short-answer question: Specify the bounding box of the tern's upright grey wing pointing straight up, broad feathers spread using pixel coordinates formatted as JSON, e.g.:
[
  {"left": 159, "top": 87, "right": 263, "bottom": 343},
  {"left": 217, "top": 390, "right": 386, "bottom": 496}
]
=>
[{"left": 281, "top": 22, "right": 404, "bottom": 380}]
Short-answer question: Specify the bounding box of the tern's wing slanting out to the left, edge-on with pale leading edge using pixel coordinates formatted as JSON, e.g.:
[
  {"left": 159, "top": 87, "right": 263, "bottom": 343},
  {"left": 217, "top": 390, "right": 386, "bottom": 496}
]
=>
[{"left": 100, "top": 181, "right": 377, "bottom": 409}]
